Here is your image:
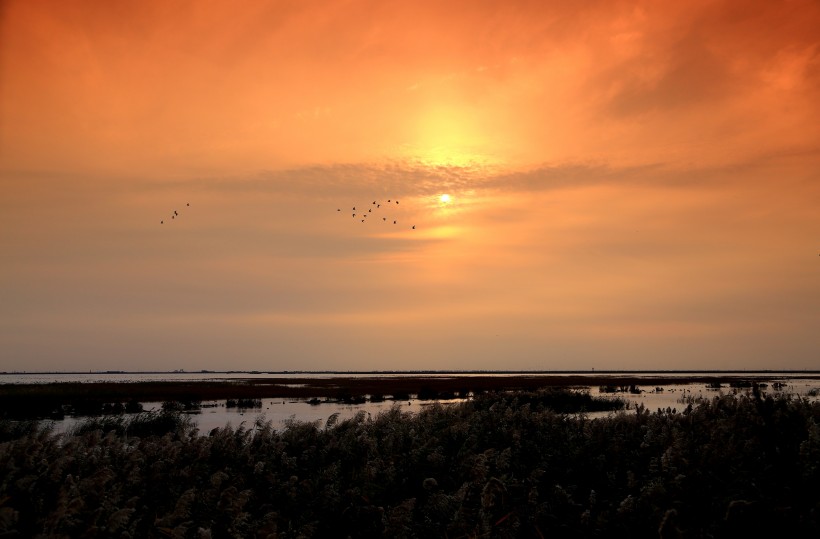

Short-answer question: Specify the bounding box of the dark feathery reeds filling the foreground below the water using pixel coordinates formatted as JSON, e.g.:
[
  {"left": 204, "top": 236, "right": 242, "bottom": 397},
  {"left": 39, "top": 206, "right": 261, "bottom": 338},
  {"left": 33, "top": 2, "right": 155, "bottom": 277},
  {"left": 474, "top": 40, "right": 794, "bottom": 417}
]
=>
[{"left": 0, "top": 390, "right": 820, "bottom": 538}]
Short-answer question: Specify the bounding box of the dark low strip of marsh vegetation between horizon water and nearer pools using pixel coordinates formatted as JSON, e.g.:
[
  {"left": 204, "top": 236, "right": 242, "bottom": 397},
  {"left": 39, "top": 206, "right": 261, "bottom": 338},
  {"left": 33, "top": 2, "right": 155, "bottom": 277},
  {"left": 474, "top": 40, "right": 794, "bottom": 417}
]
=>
[{"left": 0, "top": 375, "right": 778, "bottom": 419}]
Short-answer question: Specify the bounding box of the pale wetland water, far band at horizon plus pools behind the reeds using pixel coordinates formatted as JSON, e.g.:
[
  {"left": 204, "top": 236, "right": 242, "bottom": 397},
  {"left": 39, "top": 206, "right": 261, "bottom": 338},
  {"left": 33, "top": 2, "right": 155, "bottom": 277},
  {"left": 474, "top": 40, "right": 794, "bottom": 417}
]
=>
[{"left": 0, "top": 372, "right": 820, "bottom": 433}]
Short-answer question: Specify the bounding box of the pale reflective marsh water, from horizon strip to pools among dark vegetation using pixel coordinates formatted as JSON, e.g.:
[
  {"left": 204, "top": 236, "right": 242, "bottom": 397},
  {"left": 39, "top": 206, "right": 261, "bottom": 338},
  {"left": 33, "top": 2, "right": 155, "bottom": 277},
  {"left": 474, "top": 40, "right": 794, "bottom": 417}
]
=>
[{"left": 0, "top": 371, "right": 820, "bottom": 434}]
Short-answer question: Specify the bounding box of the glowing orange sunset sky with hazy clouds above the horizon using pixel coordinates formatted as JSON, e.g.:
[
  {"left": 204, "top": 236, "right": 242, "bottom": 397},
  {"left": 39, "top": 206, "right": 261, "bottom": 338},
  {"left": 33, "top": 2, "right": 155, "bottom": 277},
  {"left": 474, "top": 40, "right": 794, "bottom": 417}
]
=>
[{"left": 0, "top": 0, "right": 820, "bottom": 372}]
